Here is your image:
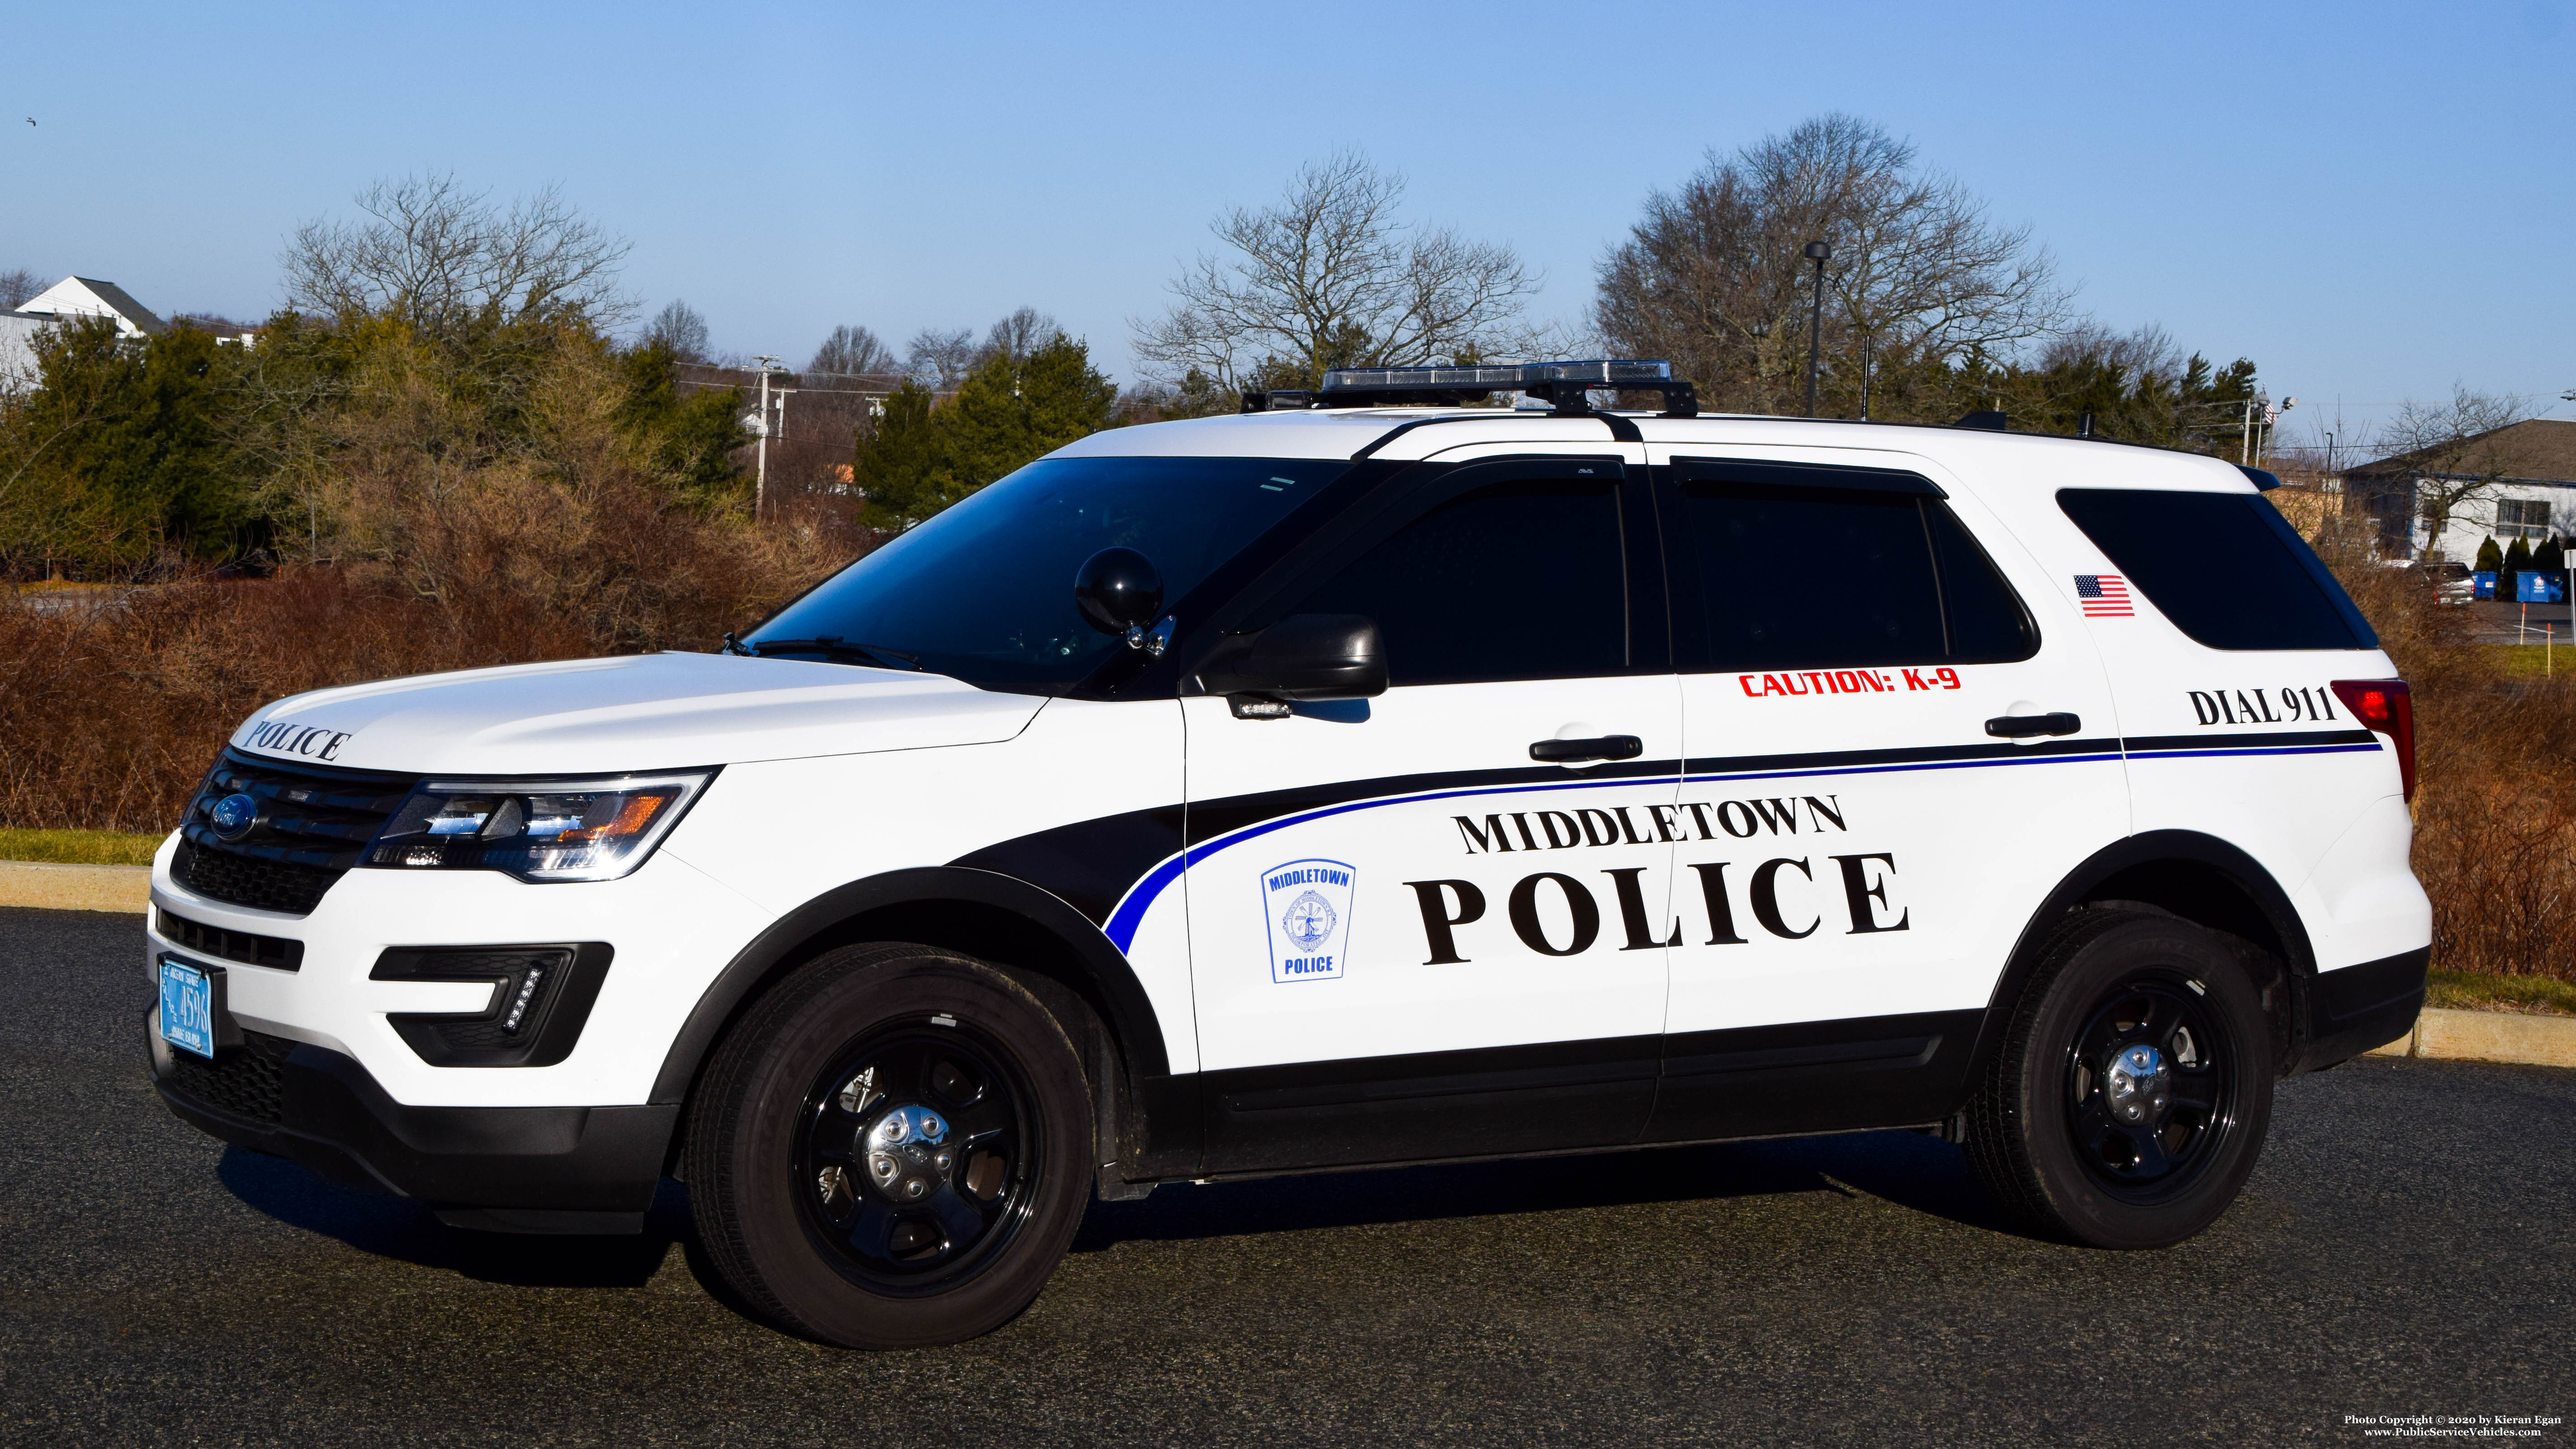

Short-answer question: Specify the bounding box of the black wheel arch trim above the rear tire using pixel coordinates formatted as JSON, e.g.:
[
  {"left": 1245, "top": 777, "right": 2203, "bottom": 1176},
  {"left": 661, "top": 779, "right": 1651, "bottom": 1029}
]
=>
[{"left": 1970, "top": 830, "right": 2316, "bottom": 1080}]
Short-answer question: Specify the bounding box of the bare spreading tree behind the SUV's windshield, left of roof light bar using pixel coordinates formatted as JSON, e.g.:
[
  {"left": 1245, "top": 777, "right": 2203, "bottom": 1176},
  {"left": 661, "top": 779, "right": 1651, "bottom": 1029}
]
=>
[{"left": 1128, "top": 152, "right": 1538, "bottom": 389}]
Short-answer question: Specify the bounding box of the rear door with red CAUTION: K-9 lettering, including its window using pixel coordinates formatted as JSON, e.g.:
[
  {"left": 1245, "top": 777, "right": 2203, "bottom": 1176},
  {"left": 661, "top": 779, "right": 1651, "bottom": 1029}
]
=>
[{"left": 1651, "top": 446, "right": 2128, "bottom": 1140}]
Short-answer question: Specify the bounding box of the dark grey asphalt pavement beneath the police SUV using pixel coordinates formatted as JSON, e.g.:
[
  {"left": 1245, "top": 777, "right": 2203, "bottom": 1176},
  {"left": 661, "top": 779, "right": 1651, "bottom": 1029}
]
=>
[{"left": 0, "top": 910, "right": 2576, "bottom": 1449}]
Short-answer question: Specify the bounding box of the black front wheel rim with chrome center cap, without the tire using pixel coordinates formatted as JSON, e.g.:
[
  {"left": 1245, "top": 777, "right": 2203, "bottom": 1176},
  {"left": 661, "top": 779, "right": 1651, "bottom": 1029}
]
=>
[{"left": 791, "top": 1023, "right": 1038, "bottom": 1294}]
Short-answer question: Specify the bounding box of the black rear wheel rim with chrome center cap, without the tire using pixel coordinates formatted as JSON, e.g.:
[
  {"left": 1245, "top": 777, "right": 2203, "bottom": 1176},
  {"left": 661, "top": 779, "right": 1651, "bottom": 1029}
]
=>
[{"left": 2066, "top": 972, "right": 2241, "bottom": 1204}]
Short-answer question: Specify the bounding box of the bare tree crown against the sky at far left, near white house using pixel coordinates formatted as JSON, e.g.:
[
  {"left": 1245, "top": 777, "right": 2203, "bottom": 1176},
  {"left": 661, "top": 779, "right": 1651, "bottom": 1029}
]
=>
[{"left": 278, "top": 175, "right": 631, "bottom": 335}]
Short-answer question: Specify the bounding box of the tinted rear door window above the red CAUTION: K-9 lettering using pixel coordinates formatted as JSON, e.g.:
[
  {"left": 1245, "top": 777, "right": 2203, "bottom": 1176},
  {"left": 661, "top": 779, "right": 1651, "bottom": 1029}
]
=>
[{"left": 1682, "top": 482, "right": 2030, "bottom": 670}]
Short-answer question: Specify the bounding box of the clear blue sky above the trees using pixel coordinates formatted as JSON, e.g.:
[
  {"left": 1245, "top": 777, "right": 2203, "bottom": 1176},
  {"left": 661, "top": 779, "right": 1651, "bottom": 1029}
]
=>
[{"left": 0, "top": 0, "right": 2576, "bottom": 438}]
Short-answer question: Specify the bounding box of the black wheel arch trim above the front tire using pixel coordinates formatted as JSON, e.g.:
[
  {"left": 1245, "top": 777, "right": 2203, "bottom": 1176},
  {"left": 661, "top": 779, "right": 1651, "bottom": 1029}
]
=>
[{"left": 649, "top": 867, "right": 1172, "bottom": 1103}]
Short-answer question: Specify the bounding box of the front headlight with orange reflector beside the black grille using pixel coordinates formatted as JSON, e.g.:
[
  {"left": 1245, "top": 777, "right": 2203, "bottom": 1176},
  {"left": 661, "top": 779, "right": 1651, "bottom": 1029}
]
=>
[{"left": 366, "top": 771, "right": 716, "bottom": 882}]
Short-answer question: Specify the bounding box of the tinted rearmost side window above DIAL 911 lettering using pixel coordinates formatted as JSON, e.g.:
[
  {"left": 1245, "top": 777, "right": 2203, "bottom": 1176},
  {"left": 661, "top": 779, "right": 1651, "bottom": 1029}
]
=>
[{"left": 2058, "top": 488, "right": 2380, "bottom": 650}]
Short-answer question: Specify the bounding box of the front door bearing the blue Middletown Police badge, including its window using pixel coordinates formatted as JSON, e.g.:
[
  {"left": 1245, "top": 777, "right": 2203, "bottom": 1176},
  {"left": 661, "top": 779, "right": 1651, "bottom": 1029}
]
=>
[{"left": 1182, "top": 449, "right": 1682, "bottom": 1173}]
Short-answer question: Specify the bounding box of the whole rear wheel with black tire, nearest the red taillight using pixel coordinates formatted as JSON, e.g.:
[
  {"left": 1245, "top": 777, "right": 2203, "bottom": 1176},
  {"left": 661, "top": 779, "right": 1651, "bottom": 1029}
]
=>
[{"left": 1968, "top": 908, "right": 2275, "bottom": 1248}]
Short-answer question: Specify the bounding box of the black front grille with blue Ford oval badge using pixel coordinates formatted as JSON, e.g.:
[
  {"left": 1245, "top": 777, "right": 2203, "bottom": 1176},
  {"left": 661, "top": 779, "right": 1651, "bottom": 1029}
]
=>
[{"left": 170, "top": 750, "right": 417, "bottom": 915}]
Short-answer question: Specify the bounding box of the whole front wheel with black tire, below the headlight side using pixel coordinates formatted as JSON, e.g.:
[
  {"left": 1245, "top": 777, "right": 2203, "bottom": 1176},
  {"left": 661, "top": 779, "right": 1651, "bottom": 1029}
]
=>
[{"left": 682, "top": 946, "right": 1092, "bottom": 1349}]
